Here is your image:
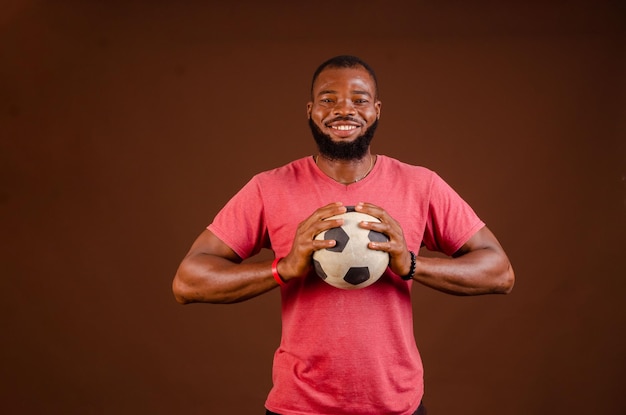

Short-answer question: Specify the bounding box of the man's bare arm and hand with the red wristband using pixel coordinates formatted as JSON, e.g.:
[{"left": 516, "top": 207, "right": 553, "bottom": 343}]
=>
[{"left": 172, "top": 203, "right": 346, "bottom": 304}]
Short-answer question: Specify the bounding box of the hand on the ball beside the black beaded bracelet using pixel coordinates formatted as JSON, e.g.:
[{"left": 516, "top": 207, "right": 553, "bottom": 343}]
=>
[{"left": 354, "top": 202, "right": 411, "bottom": 275}]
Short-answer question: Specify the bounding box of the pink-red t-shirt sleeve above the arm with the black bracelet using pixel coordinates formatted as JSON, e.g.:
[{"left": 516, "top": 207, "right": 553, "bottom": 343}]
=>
[{"left": 424, "top": 174, "right": 485, "bottom": 255}]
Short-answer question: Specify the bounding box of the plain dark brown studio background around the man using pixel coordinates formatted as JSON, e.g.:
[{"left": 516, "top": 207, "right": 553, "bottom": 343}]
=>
[{"left": 0, "top": 0, "right": 626, "bottom": 415}]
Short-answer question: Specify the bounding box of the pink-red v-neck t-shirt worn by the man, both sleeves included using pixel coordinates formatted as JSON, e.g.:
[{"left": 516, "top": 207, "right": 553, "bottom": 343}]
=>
[{"left": 208, "top": 156, "right": 484, "bottom": 415}]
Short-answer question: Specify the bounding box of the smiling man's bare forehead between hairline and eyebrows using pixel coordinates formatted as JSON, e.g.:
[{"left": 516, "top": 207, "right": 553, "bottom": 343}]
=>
[{"left": 313, "top": 66, "right": 376, "bottom": 96}]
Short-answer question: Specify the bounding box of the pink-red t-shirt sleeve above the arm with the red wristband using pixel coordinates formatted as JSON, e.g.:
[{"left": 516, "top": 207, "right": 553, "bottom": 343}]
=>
[{"left": 207, "top": 177, "right": 270, "bottom": 259}]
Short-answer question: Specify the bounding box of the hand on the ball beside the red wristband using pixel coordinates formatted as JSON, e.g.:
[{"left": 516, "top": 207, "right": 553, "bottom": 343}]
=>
[{"left": 277, "top": 202, "right": 346, "bottom": 281}]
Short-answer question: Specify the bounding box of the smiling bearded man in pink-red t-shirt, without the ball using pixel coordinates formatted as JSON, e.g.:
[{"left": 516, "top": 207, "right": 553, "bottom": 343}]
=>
[{"left": 173, "top": 56, "right": 514, "bottom": 415}]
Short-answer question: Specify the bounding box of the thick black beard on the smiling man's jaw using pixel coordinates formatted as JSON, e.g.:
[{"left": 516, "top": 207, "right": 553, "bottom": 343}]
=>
[{"left": 309, "top": 118, "right": 378, "bottom": 161}]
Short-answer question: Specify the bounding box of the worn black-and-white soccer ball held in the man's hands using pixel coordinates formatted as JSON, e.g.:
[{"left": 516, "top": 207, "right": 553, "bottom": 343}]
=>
[{"left": 313, "top": 207, "right": 389, "bottom": 290}]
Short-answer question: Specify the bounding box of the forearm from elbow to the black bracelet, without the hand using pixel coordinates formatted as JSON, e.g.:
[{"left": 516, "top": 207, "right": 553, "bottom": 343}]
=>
[{"left": 413, "top": 248, "right": 515, "bottom": 295}]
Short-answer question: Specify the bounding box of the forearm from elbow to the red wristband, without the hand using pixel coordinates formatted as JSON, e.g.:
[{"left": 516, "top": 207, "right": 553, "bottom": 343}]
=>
[{"left": 172, "top": 254, "right": 277, "bottom": 304}]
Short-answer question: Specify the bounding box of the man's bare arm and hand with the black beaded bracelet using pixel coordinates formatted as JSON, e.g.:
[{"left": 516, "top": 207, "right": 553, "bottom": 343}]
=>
[{"left": 357, "top": 204, "right": 515, "bottom": 295}]
